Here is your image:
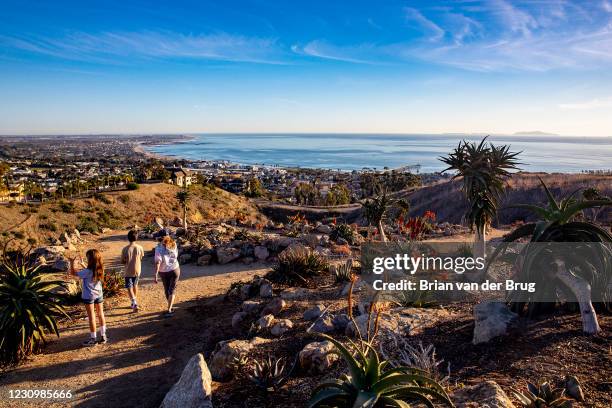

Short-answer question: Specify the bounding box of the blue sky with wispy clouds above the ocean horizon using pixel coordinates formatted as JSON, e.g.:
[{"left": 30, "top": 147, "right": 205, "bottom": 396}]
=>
[{"left": 0, "top": 0, "right": 612, "bottom": 136}]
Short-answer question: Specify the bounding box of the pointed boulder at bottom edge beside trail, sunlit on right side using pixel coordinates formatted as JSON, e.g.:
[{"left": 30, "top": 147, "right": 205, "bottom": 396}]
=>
[{"left": 160, "top": 353, "right": 212, "bottom": 408}]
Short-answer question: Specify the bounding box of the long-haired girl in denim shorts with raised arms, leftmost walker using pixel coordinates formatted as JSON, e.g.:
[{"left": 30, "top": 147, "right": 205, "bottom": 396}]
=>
[{"left": 70, "top": 249, "right": 107, "bottom": 346}]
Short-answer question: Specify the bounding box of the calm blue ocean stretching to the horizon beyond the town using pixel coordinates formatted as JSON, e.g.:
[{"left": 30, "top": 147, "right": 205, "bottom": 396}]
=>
[{"left": 147, "top": 134, "right": 612, "bottom": 173}]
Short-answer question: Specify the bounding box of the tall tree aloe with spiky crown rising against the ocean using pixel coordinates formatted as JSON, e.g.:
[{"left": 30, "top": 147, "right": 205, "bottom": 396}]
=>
[{"left": 439, "top": 136, "right": 520, "bottom": 270}]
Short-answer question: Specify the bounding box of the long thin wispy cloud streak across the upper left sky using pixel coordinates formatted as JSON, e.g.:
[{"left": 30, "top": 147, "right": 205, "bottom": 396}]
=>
[{"left": 0, "top": 31, "right": 282, "bottom": 64}]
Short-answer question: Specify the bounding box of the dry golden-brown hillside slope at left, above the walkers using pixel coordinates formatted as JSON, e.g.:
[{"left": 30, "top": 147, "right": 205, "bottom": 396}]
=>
[{"left": 0, "top": 184, "right": 265, "bottom": 244}]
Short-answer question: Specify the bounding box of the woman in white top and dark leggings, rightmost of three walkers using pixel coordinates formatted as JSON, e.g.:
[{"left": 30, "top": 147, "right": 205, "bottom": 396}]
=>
[{"left": 155, "top": 230, "right": 181, "bottom": 317}]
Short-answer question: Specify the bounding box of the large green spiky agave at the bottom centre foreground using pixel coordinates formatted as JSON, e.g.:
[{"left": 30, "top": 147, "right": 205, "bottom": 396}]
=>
[{"left": 308, "top": 335, "right": 453, "bottom": 408}]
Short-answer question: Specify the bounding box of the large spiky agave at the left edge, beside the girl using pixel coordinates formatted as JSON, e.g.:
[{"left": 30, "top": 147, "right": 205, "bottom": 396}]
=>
[{"left": 0, "top": 261, "right": 67, "bottom": 364}]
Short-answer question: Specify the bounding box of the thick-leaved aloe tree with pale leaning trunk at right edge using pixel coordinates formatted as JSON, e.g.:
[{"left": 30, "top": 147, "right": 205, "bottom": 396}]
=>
[{"left": 491, "top": 179, "right": 612, "bottom": 334}]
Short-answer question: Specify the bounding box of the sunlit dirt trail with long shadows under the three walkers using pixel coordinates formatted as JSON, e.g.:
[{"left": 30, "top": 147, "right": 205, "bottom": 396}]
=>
[{"left": 0, "top": 231, "right": 267, "bottom": 407}]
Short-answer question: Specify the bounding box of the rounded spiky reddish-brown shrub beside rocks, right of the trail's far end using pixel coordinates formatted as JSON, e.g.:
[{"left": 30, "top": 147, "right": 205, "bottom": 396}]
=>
[{"left": 266, "top": 246, "right": 329, "bottom": 285}]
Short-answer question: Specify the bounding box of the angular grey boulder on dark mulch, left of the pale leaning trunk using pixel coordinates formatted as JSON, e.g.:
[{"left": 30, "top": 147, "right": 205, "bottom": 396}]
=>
[{"left": 472, "top": 301, "right": 518, "bottom": 344}]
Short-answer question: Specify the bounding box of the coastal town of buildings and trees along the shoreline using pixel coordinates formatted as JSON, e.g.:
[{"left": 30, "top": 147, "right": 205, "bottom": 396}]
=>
[{"left": 0, "top": 136, "right": 428, "bottom": 205}]
